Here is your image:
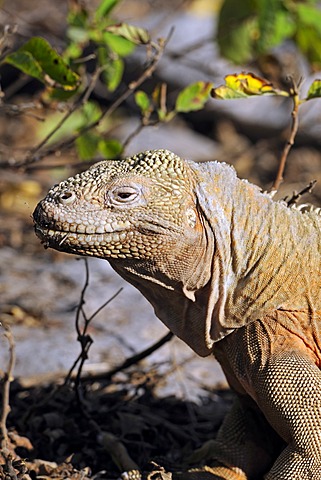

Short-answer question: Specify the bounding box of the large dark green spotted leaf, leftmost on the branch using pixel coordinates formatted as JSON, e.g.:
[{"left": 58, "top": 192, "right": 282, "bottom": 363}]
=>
[{"left": 4, "top": 37, "right": 80, "bottom": 90}]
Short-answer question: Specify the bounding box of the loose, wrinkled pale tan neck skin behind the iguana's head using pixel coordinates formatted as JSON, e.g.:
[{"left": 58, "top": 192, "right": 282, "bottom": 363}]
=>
[{"left": 192, "top": 162, "right": 321, "bottom": 347}]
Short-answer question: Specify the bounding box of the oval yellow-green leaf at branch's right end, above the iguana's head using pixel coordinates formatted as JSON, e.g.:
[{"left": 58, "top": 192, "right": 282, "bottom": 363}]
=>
[{"left": 175, "top": 82, "right": 213, "bottom": 112}]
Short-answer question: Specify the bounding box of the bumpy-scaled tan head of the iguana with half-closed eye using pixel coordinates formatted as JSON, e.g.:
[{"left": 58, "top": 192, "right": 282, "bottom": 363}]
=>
[{"left": 34, "top": 150, "right": 209, "bottom": 288}]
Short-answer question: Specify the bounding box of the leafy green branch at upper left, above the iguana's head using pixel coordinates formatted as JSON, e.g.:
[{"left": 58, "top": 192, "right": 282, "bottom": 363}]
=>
[{"left": 0, "top": 0, "right": 212, "bottom": 168}]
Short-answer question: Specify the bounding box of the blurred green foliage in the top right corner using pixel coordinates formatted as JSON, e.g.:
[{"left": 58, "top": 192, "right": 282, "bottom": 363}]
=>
[{"left": 217, "top": 0, "right": 321, "bottom": 70}]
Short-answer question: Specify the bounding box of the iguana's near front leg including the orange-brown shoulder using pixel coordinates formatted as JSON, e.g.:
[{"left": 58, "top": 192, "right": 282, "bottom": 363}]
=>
[{"left": 212, "top": 318, "right": 321, "bottom": 480}]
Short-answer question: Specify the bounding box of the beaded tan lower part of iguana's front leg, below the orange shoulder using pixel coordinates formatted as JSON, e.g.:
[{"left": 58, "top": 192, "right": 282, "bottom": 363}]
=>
[{"left": 257, "top": 351, "right": 321, "bottom": 480}]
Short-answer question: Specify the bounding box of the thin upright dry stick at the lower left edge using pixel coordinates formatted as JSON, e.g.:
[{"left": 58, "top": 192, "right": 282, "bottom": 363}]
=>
[{"left": 0, "top": 325, "right": 16, "bottom": 451}]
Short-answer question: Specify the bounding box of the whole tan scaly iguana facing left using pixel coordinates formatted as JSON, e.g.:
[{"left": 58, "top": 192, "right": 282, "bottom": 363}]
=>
[{"left": 34, "top": 150, "right": 321, "bottom": 480}]
